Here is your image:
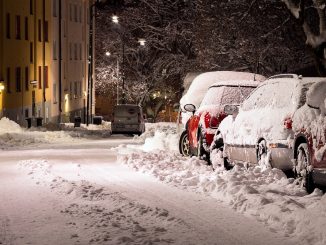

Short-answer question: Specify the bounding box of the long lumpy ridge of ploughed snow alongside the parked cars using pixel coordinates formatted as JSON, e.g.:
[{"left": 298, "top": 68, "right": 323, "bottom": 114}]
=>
[{"left": 119, "top": 124, "right": 326, "bottom": 245}]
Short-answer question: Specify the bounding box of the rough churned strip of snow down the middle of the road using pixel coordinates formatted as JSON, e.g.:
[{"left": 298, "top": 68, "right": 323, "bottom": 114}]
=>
[{"left": 19, "top": 160, "right": 191, "bottom": 244}]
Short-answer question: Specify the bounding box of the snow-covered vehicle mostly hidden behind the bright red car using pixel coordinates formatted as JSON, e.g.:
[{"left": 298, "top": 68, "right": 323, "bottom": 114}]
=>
[{"left": 179, "top": 71, "right": 265, "bottom": 156}]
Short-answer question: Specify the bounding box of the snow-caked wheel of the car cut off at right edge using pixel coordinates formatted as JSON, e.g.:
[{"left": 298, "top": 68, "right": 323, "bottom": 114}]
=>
[{"left": 294, "top": 143, "right": 315, "bottom": 193}]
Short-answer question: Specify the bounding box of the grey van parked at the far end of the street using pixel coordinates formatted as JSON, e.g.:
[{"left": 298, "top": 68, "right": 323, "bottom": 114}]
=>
[{"left": 111, "top": 104, "right": 145, "bottom": 135}]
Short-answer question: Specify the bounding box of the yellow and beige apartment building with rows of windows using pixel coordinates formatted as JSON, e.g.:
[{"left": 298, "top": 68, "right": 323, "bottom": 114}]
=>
[{"left": 0, "top": 0, "right": 94, "bottom": 125}]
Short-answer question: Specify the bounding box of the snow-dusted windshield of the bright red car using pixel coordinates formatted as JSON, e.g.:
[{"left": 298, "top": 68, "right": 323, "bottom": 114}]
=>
[{"left": 201, "top": 86, "right": 254, "bottom": 106}]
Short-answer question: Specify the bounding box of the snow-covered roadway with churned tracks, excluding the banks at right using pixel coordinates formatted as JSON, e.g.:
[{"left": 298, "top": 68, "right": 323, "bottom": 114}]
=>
[{"left": 0, "top": 136, "right": 295, "bottom": 244}]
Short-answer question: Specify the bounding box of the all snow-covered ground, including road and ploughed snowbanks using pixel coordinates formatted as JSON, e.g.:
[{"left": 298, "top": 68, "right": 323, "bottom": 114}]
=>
[{"left": 0, "top": 118, "right": 326, "bottom": 244}]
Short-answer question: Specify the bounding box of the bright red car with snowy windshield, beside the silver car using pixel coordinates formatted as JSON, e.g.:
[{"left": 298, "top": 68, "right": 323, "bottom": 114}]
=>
[{"left": 184, "top": 80, "right": 260, "bottom": 160}]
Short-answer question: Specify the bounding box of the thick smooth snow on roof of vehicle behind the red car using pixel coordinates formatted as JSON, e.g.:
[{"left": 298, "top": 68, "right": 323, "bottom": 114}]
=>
[{"left": 180, "top": 71, "right": 266, "bottom": 107}]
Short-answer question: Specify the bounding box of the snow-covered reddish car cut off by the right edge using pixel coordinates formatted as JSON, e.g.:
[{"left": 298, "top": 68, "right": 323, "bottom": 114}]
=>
[{"left": 293, "top": 79, "right": 326, "bottom": 193}]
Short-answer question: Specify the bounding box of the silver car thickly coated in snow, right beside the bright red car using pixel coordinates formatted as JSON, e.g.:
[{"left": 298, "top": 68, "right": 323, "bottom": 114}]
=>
[{"left": 215, "top": 74, "right": 325, "bottom": 171}]
